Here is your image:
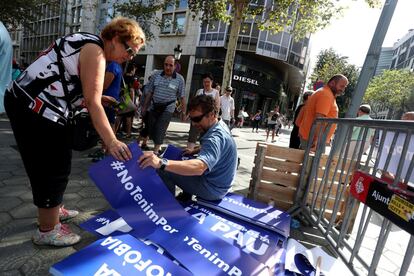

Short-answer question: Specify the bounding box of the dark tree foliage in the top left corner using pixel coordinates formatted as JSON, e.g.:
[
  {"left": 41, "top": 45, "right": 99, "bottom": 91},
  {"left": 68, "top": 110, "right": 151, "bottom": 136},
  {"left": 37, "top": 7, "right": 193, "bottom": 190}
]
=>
[{"left": 0, "top": 0, "right": 59, "bottom": 29}]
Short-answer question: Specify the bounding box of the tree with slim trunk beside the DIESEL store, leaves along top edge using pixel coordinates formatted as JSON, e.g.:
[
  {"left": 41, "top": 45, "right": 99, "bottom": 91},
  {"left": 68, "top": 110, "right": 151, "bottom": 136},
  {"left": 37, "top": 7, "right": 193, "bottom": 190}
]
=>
[{"left": 117, "top": 0, "right": 379, "bottom": 87}]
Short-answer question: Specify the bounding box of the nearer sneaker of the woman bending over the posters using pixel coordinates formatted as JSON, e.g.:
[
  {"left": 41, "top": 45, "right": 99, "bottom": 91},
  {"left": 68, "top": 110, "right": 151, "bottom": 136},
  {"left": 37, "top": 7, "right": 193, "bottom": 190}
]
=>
[{"left": 32, "top": 223, "right": 81, "bottom": 246}]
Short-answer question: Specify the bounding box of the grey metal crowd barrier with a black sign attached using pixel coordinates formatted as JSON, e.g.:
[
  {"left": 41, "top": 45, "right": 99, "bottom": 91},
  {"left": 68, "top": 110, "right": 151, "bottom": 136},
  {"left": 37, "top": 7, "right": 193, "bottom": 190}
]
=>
[{"left": 290, "top": 118, "right": 414, "bottom": 275}]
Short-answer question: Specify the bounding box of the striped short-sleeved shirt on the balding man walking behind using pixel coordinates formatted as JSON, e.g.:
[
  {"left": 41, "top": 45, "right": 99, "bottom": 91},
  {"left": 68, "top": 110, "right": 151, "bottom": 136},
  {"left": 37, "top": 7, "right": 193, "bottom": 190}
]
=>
[{"left": 147, "top": 71, "right": 185, "bottom": 113}]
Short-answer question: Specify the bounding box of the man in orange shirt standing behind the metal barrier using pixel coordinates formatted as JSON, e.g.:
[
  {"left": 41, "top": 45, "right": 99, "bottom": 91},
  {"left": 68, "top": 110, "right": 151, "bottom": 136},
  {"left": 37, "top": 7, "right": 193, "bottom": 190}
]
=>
[{"left": 296, "top": 74, "right": 348, "bottom": 151}]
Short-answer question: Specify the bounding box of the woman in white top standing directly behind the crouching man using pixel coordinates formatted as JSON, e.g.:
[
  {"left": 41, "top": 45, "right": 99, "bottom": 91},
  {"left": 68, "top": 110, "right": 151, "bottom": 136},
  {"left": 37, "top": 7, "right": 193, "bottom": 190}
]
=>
[{"left": 187, "top": 73, "right": 220, "bottom": 150}]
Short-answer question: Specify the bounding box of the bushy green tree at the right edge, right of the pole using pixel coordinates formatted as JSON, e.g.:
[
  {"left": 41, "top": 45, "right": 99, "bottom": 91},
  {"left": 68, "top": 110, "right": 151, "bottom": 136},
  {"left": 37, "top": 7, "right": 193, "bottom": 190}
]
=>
[{"left": 364, "top": 70, "right": 414, "bottom": 116}]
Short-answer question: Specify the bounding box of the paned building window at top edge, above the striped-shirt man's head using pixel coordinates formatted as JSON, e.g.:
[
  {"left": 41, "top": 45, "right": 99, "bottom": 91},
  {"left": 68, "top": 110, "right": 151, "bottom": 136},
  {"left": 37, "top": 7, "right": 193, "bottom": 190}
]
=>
[{"left": 161, "top": 0, "right": 188, "bottom": 34}]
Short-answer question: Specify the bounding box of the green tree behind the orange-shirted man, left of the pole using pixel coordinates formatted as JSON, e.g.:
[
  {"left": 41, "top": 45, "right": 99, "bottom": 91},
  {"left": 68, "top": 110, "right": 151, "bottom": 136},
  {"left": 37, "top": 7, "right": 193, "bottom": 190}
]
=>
[{"left": 310, "top": 48, "right": 359, "bottom": 117}]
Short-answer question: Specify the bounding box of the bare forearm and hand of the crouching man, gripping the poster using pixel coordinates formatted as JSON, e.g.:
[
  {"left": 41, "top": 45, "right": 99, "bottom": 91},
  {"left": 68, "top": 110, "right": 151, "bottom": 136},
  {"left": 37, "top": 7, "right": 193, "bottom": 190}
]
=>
[{"left": 138, "top": 151, "right": 208, "bottom": 176}]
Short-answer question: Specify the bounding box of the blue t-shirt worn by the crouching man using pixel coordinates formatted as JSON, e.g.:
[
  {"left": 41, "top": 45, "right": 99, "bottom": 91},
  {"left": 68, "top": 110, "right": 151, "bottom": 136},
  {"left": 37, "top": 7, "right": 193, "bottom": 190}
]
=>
[{"left": 197, "top": 121, "right": 237, "bottom": 194}]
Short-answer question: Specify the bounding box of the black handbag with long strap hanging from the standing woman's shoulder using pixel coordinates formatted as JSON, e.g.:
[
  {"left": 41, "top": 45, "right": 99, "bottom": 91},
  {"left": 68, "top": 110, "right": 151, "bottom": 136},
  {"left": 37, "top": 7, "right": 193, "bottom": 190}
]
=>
[{"left": 53, "top": 38, "right": 99, "bottom": 151}]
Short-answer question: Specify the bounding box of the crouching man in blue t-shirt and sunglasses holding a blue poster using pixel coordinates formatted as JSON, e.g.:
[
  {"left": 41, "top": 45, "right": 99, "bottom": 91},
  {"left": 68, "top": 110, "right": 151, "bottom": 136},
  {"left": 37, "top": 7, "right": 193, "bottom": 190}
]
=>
[{"left": 138, "top": 95, "right": 237, "bottom": 200}]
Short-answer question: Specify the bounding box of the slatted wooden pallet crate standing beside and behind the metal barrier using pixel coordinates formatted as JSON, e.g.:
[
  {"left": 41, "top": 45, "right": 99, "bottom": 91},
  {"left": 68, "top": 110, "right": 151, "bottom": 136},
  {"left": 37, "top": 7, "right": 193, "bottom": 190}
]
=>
[{"left": 248, "top": 143, "right": 355, "bottom": 225}]
